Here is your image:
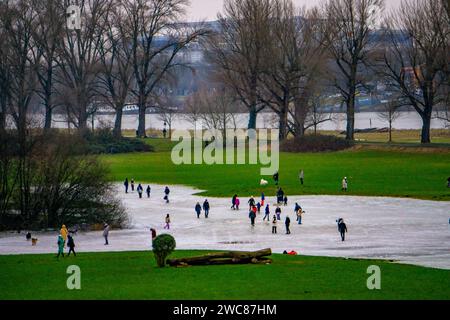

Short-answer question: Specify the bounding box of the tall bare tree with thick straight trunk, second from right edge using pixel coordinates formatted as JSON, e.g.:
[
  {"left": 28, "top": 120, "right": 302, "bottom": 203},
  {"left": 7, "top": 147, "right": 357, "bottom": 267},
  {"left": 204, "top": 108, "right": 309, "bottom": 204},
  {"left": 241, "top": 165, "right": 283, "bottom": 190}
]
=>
[{"left": 324, "top": 0, "right": 384, "bottom": 140}]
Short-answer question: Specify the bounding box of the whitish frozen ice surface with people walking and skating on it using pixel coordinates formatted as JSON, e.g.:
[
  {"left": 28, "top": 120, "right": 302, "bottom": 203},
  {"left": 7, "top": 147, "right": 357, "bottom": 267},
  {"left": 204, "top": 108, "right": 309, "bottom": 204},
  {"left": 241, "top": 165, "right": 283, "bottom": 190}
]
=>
[{"left": 0, "top": 185, "right": 450, "bottom": 269}]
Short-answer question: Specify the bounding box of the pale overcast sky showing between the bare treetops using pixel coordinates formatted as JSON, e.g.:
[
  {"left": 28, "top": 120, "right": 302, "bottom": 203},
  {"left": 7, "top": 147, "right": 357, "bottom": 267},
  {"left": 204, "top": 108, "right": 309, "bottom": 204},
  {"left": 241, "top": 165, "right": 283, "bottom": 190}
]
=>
[{"left": 187, "top": 0, "right": 401, "bottom": 21}]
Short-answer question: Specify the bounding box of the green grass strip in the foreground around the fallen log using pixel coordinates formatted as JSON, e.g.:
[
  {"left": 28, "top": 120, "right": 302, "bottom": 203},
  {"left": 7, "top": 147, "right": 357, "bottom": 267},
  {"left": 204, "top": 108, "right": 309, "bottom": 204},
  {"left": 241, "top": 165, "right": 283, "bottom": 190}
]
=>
[{"left": 0, "top": 251, "right": 450, "bottom": 300}]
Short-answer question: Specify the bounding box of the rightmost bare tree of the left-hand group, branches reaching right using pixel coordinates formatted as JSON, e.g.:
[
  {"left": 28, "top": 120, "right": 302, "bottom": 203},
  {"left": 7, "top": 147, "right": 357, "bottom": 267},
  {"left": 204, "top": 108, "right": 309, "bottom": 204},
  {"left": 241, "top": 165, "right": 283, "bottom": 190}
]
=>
[{"left": 121, "top": 0, "right": 206, "bottom": 137}]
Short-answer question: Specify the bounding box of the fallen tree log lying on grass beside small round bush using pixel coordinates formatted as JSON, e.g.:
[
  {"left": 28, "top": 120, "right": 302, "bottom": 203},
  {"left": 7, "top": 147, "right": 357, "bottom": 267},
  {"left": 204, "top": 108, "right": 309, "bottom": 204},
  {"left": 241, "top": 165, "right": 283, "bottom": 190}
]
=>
[{"left": 167, "top": 249, "right": 272, "bottom": 266}]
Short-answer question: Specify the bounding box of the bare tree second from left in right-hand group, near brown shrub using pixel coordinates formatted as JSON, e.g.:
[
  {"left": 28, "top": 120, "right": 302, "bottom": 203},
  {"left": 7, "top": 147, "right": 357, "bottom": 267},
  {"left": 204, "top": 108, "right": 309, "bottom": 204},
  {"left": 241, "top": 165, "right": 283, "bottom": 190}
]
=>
[{"left": 260, "top": 0, "right": 326, "bottom": 140}]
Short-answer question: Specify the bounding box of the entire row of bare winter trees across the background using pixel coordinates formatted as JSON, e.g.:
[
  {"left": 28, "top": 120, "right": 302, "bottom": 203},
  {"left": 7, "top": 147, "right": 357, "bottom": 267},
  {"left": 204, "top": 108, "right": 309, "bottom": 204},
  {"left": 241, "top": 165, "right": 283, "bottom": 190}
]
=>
[{"left": 0, "top": 0, "right": 450, "bottom": 143}]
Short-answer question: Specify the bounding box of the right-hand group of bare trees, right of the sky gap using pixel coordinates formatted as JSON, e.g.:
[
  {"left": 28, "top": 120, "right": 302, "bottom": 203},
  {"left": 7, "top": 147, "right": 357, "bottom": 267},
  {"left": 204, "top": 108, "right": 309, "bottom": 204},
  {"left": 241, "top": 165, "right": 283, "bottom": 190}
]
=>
[{"left": 205, "top": 0, "right": 450, "bottom": 143}]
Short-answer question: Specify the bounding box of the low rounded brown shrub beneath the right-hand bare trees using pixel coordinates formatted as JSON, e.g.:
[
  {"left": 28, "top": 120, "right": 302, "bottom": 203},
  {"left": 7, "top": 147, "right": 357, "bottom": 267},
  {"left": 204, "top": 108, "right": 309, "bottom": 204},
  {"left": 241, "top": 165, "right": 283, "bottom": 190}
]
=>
[{"left": 280, "top": 135, "right": 353, "bottom": 152}]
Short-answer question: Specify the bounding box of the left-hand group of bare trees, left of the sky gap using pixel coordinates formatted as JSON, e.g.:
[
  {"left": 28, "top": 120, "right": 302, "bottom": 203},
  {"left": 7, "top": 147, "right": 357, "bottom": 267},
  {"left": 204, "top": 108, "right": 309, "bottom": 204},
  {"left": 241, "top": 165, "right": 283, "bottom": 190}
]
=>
[{"left": 0, "top": 0, "right": 206, "bottom": 136}]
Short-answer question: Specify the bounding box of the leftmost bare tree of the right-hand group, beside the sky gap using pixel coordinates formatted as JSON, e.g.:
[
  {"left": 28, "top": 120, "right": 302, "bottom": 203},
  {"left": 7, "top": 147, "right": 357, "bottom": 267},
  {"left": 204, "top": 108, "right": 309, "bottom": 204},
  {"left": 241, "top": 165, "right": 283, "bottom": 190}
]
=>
[{"left": 206, "top": 0, "right": 272, "bottom": 129}]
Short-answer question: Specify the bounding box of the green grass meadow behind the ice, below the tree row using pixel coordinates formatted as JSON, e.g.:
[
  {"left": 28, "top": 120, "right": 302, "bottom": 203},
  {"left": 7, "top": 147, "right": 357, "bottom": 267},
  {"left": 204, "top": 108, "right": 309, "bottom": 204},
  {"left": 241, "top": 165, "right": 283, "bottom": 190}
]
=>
[{"left": 101, "top": 144, "right": 450, "bottom": 201}]
